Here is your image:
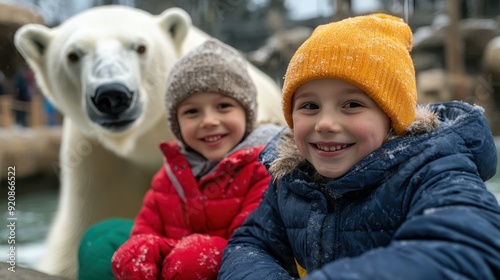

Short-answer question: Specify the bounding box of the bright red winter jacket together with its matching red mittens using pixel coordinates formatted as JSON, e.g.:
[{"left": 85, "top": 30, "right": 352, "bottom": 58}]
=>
[{"left": 112, "top": 142, "right": 270, "bottom": 280}]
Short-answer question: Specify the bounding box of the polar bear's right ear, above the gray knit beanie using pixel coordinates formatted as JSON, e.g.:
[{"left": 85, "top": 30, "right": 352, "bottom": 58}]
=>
[{"left": 158, "top": 8, "right": 192, "bottom": 49}]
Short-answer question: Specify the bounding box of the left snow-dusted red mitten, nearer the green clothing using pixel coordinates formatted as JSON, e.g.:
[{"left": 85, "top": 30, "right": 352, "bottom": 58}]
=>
[{"left": 111, "top": 234, "right": 176, "bottom": 280}]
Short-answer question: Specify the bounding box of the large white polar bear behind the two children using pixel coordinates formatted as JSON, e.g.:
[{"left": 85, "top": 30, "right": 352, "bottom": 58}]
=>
[{"left": 14, "top": 6, "right": 284, "bottom": 278}]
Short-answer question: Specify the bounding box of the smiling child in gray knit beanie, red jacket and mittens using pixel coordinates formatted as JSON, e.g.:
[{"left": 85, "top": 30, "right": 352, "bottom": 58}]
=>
[{"left": 112, "top": 39, "right": 280, "bottom": 280}]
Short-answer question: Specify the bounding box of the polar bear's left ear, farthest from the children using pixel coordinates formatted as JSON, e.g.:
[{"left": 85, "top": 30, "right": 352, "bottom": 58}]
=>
[{"left": 14, "top": 24, "right": 52, "bottom": 64}]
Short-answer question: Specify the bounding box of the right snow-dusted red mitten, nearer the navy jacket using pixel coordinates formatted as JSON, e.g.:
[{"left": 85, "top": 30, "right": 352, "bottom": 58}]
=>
[{"left": 161, "top": 234, "right": 227, "bottom": 280}]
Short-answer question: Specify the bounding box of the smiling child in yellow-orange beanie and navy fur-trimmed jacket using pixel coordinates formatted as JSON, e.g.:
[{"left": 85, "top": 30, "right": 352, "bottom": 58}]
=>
[{"left": 219, "top": 14, "right": 500, "bottom": 280}]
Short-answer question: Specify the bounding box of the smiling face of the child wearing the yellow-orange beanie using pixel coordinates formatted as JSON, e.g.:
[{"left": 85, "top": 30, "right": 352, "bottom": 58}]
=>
[{"left": 292, "top": 79, "right": 391, "bottom": 178}]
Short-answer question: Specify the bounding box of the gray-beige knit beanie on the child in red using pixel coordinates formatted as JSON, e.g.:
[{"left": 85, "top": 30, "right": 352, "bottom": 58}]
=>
[{"left": 166, "top": 38, "right": 257, "bottom": 141}]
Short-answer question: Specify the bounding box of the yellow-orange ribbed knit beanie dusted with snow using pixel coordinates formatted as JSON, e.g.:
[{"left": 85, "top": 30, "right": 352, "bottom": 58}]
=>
[{"left": 283, "top": 14, "right": 417, "bottom": 135}]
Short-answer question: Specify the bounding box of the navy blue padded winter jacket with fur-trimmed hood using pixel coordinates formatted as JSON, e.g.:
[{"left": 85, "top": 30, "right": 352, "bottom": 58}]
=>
[{"left": 219, "top": 102, "right": 500, "bottom": 280}]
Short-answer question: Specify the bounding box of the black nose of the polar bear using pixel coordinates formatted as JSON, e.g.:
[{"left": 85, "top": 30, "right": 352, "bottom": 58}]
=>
[{"left": 92, "top": 83, "right": 133, "bottom": 116}]
